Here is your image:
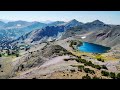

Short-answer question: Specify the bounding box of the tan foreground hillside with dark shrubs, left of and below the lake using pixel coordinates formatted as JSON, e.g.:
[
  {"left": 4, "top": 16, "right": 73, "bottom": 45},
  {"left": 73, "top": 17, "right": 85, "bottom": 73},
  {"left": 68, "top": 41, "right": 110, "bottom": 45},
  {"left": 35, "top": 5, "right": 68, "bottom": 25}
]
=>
[{"left": 7, "top": 38, "right": 119, "bottom": 79}]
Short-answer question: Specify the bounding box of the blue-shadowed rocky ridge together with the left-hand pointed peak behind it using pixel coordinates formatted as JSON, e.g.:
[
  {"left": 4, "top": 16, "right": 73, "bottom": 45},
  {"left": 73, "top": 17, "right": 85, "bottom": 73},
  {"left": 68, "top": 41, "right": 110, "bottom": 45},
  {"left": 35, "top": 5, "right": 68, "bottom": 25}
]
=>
[{"left": 12, "top": 19, "right": 82, "bottom": 43}]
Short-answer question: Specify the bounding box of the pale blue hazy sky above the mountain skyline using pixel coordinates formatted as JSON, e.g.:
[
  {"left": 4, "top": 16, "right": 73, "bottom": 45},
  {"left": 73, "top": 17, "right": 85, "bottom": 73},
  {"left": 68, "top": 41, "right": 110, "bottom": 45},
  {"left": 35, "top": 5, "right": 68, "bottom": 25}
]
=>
[{"left": 0, "top": 11, "right": 120, "bottom": 25}]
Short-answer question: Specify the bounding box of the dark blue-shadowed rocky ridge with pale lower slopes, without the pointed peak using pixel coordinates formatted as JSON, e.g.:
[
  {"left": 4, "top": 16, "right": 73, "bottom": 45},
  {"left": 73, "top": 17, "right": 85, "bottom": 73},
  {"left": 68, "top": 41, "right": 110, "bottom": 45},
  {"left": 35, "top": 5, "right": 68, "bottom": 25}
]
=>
[{"left": 16, "top": 26, "right": 65, "bottom": 43}]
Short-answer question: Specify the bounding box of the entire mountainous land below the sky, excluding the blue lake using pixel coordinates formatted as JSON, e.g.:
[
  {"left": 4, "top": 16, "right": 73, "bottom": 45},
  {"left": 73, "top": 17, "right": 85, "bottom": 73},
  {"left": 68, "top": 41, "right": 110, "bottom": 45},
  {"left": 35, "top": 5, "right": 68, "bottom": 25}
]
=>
[{"left": 0, "top": 19, "right": 120, "bottom": 79}]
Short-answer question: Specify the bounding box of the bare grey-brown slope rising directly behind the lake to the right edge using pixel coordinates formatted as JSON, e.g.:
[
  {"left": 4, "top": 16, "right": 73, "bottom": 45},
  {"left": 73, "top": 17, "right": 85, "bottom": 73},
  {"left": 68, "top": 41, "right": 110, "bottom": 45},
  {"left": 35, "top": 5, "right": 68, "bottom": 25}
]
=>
[{"left": 85, "top": 26, "right": 120, "bottom": 47}]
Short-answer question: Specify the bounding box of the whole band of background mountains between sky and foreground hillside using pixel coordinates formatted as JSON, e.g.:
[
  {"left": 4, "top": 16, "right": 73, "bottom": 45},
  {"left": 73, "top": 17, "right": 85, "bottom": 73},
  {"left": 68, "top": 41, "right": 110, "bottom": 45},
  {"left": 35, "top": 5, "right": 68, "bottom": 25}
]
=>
[{"left": 0, "top": 19, "right": 120, "bottom": 46}]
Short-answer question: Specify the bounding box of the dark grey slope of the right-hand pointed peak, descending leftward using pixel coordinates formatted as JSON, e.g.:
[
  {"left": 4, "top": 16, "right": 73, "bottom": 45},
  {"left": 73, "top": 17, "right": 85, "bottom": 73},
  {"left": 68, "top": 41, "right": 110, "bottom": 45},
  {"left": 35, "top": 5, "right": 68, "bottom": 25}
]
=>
[{"left": 62, "top": 20, "right": 111, "bottom": 39}]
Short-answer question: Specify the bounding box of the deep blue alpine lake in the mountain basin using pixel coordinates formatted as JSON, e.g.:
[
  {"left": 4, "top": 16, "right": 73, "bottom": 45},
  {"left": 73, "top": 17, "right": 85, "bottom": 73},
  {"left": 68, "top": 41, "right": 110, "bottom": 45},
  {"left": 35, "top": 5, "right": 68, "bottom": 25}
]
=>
[{"left": 78, "top": 42, "right": 110, "bottom": 53}]
